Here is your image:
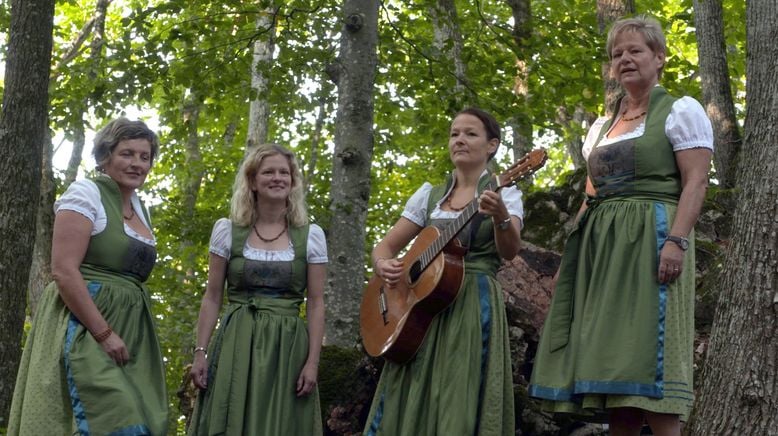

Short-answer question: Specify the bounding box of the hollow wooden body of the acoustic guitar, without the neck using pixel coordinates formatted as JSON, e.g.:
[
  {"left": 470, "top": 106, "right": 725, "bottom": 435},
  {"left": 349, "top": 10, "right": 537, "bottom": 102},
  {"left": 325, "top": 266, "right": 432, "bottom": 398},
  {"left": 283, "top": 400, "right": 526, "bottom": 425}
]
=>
[{"left": 359, "top": 226, "right": 465, "bottom": 363}]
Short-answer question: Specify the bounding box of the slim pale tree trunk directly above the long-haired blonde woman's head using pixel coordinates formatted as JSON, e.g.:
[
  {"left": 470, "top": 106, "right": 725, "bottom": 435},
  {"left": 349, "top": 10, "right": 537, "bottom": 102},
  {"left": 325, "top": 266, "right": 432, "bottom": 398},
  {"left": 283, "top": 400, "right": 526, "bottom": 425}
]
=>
[{"left": 246, "top": 4, "right": 278, "bottom": 153}]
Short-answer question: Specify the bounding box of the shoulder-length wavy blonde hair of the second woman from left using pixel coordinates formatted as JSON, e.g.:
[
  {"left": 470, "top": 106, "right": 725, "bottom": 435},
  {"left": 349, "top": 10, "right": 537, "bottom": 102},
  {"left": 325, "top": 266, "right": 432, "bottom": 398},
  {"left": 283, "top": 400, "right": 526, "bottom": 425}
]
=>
[{"left": 230, "top": 144, "right": 308, "bottom": 227}]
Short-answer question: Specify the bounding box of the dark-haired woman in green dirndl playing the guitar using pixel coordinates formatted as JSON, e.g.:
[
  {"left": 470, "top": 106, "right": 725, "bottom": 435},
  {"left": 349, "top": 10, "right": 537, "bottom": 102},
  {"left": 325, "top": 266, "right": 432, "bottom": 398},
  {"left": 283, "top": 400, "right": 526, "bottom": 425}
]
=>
[{"left": 365, "top": 108, "right": 523, "bottom": 436}]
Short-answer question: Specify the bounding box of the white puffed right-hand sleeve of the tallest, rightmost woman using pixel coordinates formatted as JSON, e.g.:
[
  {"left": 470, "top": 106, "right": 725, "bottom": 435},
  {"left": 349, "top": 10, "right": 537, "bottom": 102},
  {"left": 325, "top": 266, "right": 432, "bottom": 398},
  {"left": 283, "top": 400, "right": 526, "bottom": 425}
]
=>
[{"left": 665, "top": 97, "right": 713, "bottom": 151}]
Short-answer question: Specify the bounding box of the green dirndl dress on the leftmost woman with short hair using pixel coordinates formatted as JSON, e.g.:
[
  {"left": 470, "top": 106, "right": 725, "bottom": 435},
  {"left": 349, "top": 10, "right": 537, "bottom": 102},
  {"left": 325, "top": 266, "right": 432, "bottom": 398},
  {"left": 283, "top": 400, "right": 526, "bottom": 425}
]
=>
[{"left": 8, "top": 177, "right": 168, "bottom": 436}]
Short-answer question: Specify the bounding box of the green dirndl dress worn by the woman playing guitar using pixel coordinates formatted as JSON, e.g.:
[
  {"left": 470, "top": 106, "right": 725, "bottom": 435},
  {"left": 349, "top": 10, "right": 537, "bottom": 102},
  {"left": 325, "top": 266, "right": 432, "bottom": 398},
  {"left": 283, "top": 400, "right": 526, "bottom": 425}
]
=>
[{"left": 364, "top": 172, "right": 515, "bottom": 436}]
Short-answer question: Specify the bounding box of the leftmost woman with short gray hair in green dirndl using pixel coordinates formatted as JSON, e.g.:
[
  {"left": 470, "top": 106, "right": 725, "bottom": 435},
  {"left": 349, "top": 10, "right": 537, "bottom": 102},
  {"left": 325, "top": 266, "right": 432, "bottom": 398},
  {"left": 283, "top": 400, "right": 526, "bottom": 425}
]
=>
[{"left": 8, "top": 118, "right": 168, "bottom": 436}]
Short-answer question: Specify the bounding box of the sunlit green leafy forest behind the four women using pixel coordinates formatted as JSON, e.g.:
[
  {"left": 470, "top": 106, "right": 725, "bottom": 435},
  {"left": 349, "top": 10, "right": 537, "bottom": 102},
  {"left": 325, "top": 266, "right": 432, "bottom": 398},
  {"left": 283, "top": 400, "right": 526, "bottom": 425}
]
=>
[{"left": 0, "top": 0, "right": 778, "bottom": 434}]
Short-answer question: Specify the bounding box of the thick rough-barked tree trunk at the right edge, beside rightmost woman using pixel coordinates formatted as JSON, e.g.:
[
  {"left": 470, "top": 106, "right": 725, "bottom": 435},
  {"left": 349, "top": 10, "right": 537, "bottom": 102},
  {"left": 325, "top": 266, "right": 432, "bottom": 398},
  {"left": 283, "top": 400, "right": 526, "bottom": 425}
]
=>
[{"left": 688, "top": 0, "right": 778, "bottom": 436}]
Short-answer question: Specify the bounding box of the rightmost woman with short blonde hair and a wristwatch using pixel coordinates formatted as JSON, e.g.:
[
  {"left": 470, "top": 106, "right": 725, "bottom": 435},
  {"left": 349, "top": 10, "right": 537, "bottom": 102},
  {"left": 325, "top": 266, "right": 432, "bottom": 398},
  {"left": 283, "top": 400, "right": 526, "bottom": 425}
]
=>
[{"left": 529, "top": 17, "right": 713, "bottom": 436}]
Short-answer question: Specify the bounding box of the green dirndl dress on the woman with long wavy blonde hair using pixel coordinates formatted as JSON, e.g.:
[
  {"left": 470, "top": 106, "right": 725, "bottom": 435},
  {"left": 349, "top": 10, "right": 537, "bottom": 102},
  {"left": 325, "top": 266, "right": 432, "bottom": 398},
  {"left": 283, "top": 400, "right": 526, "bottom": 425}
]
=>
[{"left": 189, "top": 224, "right": 322, "bottom": 436}]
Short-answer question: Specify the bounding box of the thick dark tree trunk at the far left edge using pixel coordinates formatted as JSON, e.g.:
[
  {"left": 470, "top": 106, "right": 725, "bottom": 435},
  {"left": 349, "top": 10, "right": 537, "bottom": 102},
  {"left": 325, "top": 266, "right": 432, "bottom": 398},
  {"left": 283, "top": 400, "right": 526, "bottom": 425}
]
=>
[{"left": 0, "top": 0, "right": 54, "bottom": 427}]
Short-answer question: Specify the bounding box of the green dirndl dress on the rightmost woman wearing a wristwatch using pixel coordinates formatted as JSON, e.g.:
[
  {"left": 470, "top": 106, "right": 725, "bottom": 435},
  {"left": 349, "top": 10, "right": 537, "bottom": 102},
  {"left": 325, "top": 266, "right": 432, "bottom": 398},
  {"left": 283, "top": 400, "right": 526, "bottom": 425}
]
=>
[{"left": 529, "top": 87, "right": 695, "bottom": 421}]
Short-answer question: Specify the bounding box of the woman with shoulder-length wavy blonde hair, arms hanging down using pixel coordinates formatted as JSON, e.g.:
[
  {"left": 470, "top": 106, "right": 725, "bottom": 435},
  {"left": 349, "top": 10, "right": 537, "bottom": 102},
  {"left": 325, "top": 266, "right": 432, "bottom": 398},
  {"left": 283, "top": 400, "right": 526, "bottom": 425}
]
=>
[{"left": 189, "top": 144, "right": 327, "bottom": 435}]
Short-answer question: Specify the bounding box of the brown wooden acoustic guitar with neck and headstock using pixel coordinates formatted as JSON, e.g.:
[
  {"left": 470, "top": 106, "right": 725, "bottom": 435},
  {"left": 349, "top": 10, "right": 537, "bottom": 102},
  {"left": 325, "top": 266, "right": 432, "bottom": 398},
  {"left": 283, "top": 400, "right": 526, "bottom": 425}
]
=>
[{"left": 359, "top": 150, "right": 547, "bottom": 363}]
